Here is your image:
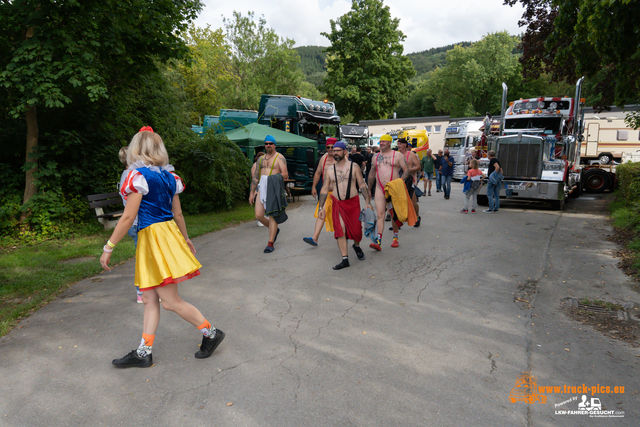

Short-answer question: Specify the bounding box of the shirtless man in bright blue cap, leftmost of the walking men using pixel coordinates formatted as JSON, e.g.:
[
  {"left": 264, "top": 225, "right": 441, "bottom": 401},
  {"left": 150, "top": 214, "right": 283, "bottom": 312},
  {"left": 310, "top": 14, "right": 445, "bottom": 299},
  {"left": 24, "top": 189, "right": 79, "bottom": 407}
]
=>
[{"left": 249, "top": 135, "right": 289, "bottom": 253}]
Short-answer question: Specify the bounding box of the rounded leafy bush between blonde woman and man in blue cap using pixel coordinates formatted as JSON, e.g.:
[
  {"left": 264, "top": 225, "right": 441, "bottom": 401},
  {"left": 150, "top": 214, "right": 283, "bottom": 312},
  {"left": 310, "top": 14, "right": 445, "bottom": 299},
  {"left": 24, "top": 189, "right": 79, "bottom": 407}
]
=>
[{"left": 165, "top": 131, "right": 251, "bottom": 213}]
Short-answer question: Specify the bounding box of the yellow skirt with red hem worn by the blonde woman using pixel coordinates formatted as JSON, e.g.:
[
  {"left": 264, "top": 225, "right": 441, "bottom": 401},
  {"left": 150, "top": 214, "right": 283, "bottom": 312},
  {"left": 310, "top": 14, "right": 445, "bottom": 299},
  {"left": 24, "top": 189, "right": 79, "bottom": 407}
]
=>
[{"left": 135, "top": 220, "right": 202, "bottom": 291}]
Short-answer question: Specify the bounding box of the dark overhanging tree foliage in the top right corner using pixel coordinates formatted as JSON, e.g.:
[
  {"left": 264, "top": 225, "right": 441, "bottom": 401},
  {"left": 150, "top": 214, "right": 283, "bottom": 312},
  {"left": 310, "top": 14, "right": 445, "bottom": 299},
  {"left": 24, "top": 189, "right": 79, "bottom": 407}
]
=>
[{"left": 505, "top": 0, "right": 640, "bottom": 125}]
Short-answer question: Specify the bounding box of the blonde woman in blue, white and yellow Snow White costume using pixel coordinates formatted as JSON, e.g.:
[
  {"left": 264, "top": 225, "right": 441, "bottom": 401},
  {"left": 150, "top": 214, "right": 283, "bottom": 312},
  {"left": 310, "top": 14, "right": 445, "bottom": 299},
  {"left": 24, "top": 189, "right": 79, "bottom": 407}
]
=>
[{"left": 100, "top": 126, "right": 225, "bottom": 368}]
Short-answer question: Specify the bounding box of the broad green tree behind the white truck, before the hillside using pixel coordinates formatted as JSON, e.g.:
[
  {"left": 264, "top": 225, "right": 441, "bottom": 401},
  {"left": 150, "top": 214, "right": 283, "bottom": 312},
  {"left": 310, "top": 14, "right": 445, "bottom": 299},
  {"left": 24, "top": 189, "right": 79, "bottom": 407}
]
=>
[{"left": 426, "top": 32, "right": 521, "bottom": 117}]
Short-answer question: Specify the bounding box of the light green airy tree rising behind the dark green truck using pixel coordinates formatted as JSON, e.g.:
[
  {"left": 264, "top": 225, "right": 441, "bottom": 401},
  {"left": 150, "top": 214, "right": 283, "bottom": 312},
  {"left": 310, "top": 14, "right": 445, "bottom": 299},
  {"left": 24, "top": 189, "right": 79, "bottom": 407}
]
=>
[{"left": 224, "top": 11, "right": 304, "bottom": 110}]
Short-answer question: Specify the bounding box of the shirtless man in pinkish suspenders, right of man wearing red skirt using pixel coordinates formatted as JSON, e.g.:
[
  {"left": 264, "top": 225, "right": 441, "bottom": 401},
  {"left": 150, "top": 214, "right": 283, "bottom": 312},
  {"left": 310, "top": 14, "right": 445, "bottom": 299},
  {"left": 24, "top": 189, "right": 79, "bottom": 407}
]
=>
[{"left": 369, "top": 135, "right": 409, "bottom": 251}]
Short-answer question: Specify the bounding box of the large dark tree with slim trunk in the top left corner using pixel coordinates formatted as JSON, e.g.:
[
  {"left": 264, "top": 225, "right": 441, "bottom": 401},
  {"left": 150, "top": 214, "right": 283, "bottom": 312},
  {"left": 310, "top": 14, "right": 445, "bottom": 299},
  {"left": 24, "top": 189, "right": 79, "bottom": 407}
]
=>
[{"left": 0, "top": 0, "right": 202, "bottom": 219}]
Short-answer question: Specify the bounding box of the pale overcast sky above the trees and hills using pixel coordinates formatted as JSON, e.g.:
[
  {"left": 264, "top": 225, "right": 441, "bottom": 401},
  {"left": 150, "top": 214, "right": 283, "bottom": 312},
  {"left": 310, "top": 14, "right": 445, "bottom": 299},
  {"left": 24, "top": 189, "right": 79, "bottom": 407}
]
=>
[{"left": 196, "top": 0, "right": 522, "bottom": 53}]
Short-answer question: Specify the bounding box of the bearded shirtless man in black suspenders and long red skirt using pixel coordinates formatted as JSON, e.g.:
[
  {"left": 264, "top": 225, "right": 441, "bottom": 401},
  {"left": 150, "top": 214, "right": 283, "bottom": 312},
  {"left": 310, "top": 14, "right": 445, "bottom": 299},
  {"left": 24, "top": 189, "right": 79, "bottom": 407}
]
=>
[{"left": 318, "top": 141, "right": 373, "bottom": 270}]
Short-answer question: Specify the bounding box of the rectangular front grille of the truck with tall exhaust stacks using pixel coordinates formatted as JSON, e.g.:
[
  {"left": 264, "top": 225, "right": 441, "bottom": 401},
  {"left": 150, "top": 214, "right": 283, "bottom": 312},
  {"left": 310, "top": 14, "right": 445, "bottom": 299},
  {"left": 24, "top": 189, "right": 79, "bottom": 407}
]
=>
[{"left": 496, "top": 135, "right": 548, "bottom": 179}]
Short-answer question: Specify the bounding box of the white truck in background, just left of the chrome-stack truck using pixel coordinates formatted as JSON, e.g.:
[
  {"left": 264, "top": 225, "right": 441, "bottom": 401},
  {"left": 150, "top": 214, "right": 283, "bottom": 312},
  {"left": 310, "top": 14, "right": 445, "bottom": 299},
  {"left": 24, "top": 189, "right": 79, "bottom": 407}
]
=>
[{"left": 444, "top": 120, "right": 483, "bottom": 181}]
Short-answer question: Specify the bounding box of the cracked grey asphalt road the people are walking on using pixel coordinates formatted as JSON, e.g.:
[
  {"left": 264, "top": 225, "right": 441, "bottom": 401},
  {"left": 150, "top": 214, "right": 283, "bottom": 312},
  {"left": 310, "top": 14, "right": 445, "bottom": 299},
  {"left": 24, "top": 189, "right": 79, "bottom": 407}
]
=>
[{"left": 0, "top": 184, "right": 640, "bottom": 426}]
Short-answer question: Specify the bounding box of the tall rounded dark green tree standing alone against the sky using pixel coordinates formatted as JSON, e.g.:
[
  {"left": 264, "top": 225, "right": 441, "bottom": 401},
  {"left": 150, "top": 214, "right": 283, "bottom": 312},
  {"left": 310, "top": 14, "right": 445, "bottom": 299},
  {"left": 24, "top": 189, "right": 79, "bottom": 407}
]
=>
[{"left": 322, "top": 0, "right": 415, "bottom": 122}]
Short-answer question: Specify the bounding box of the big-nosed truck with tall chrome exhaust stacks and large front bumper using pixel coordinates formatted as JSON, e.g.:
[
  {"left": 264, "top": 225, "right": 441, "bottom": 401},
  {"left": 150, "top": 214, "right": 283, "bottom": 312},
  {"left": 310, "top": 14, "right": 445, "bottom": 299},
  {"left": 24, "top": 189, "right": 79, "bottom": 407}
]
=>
[{"left": 478, "top": 78, "right": 584, "bottom": 209}]
